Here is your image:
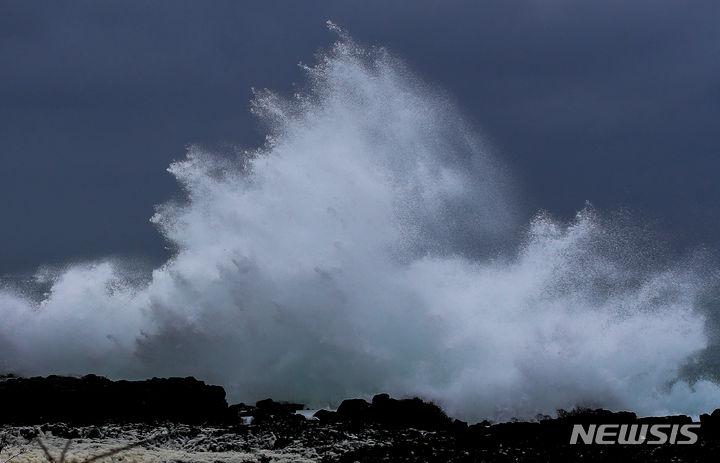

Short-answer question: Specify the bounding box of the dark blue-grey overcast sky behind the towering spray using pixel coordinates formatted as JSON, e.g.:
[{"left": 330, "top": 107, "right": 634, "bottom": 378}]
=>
[{"left": 0, "top": 0, "right": 720, "bottom": 274}]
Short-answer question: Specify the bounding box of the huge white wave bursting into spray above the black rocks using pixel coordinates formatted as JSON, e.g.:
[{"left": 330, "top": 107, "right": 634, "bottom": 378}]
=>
[{"left": 0, "top": 25, "right": 720, "bottom": 420}]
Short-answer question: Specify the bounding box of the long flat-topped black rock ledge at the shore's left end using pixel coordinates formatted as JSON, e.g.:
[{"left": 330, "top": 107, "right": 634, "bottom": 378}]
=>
[{"left": 0, "top": 375, "right": 228, "bottom": 424}]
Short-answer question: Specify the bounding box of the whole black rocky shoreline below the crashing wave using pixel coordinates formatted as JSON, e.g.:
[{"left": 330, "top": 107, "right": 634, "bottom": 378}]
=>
[{"left": 0, "top": 375, "right": 720, "bottom": 463}]
